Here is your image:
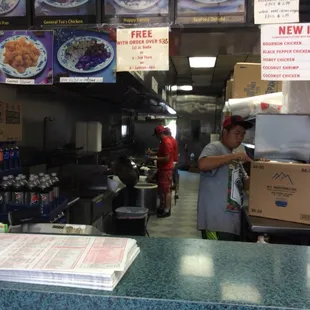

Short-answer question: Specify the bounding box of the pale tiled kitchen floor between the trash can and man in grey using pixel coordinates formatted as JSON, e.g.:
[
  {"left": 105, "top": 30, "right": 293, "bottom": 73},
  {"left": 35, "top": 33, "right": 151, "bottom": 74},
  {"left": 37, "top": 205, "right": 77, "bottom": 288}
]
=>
[{"left": 148, "top": 172, "right": 201, "bottom": 238}]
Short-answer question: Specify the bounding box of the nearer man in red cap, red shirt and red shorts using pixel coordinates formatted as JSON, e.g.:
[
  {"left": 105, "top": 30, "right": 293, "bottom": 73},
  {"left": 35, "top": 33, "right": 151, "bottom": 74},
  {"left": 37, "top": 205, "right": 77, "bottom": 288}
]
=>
[{"left": 153, "top": 125, "right": 174, "bottom": 217}]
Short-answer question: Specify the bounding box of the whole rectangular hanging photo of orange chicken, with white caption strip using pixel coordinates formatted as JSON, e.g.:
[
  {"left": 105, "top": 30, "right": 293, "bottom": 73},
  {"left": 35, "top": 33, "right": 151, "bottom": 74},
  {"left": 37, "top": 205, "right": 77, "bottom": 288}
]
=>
[{"left": 0, "top": 31, "right": 53, "bottom": 85}]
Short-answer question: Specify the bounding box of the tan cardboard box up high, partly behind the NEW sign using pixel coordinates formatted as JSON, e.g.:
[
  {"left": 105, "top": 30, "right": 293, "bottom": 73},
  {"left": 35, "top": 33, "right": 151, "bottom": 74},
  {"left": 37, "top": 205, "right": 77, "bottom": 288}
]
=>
[{"left": 232, "top": 63, "right": 282, "bottom": 98}]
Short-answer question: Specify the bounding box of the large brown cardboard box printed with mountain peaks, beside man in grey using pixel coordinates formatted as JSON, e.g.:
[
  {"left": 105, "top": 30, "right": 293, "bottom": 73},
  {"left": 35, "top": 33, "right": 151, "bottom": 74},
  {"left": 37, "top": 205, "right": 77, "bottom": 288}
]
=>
[{"left": 249, "top": 162, "right": 310, "bottom": 224}]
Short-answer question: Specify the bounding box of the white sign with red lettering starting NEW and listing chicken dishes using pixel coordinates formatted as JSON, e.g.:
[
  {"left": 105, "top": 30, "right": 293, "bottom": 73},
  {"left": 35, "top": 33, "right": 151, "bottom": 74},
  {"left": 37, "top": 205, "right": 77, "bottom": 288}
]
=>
[{"left": 261, "top": 24, "right": 310, "bottom": 81}]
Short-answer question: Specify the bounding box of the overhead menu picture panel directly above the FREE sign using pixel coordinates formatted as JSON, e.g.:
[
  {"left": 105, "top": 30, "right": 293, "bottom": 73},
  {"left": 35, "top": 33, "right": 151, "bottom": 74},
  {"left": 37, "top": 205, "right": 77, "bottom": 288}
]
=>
[{"left": 103, "top": 0, "right": 169, "bottom": 24}]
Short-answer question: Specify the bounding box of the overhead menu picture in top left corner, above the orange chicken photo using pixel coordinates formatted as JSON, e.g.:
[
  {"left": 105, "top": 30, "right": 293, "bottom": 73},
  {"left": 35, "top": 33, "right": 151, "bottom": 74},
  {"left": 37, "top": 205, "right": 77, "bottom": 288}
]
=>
[{"left": 0, "top": 0, "right": 29, "bottom": 29}]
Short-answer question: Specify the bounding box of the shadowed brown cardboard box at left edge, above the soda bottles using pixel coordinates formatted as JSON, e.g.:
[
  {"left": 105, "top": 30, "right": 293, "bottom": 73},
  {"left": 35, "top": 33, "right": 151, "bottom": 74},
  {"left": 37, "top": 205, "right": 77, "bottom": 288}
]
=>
[{"left": 0, "top": 102, "right": 23, "bottom": 142}]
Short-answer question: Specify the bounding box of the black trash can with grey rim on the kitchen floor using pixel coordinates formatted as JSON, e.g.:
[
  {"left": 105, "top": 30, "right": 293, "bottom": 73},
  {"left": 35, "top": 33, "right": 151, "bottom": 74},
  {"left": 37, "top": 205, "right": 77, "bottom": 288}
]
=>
[{"left": 115, "top": 207, "right": 148, "bottom": 236}]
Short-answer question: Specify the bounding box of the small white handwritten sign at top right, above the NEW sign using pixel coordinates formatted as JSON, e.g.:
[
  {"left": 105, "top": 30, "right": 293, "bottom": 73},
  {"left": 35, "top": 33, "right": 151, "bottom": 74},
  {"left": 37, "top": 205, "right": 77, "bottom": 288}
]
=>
[{"left": 254, "top": 0, "right": 299, "bottom": 24}]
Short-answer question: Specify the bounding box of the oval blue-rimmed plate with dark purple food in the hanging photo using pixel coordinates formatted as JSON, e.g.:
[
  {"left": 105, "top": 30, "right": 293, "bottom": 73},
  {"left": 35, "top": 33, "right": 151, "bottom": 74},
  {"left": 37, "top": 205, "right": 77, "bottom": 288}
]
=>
[{"left": 57, "top": 36, "right": 114, "bottom": 74}]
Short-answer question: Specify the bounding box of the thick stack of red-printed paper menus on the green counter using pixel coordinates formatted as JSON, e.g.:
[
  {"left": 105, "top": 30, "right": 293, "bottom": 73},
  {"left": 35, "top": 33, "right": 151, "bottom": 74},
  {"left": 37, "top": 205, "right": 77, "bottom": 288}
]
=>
[{"left": 0, "top": 234, "right": 140, "bottom": 290}]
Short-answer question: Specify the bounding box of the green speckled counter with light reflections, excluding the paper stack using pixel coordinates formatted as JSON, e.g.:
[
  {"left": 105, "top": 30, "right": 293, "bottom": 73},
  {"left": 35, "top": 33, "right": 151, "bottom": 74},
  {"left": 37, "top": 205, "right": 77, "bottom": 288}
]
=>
[{"left": 0, "top": 237, "right": 310, "bottom": 310}]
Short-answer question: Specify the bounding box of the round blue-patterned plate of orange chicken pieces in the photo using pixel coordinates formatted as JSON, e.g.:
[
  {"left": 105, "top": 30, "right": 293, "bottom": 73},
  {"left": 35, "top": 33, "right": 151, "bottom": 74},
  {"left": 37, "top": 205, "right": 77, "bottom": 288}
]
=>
[{"left": 0, "top": 35, "right": 47, "bottom": 78}]
